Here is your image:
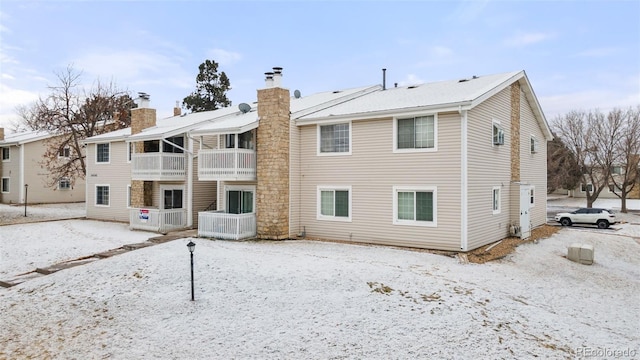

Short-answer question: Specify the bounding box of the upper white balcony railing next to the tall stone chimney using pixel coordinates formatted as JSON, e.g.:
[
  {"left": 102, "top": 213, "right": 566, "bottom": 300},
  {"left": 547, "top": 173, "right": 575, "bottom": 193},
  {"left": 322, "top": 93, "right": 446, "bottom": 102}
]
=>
[{"left": 198, "top": 149, "right": 256, "bottom": 180}]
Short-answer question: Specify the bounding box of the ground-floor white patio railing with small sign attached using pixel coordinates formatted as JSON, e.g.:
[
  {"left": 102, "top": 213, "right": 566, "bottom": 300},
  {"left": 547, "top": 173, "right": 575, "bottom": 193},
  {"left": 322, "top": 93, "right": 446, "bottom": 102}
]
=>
[{"left": 129, "top": 208, "right": 187, "bottom": 233}]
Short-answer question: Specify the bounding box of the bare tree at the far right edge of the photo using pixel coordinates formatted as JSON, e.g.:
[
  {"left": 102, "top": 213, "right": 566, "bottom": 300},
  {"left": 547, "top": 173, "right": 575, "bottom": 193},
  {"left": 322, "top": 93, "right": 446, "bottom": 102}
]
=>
[{"left": 610, "top": 106, "right": 640, "bottom": 213}]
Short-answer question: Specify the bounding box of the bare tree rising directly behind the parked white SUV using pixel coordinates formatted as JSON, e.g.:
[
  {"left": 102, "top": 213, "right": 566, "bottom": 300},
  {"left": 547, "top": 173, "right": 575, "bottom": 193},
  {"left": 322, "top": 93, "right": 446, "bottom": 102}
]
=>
[{"left": 554, "top": 110, "right": 623, "bottom": 207}]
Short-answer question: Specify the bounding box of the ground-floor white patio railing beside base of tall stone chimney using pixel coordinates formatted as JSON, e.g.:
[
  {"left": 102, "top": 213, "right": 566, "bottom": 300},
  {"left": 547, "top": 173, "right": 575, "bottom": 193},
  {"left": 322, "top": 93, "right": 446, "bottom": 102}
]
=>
[{"left": 198, "top": 211, "right": 256, "bottom": 240}]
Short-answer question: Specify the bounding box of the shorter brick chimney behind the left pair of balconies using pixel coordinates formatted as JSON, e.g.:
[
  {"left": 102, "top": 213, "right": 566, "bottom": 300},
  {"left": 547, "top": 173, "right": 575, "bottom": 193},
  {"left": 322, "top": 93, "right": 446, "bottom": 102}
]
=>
[{"left": 131, "top": 93, "right": 156, "bottom": 208}]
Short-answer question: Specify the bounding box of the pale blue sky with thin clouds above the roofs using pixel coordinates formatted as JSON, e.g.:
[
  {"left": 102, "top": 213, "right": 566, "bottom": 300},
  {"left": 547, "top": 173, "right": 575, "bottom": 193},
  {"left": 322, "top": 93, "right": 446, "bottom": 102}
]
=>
[{"left": 0, "top": 0, "right": 640, "bottom": 127}]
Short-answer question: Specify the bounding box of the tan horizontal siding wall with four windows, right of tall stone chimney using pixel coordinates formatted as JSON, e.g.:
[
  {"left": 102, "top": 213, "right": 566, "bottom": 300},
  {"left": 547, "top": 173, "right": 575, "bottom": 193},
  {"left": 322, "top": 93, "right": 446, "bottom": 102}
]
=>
[{"left": 300, "top": 114, "right": 460, "bottom": 250}]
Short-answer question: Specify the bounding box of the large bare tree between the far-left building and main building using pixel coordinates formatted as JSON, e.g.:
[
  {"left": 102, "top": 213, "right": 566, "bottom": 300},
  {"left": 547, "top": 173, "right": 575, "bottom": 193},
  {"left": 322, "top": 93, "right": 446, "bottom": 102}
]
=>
[{"left": 19, "top": 66, "right": 134, "bottom": 187}]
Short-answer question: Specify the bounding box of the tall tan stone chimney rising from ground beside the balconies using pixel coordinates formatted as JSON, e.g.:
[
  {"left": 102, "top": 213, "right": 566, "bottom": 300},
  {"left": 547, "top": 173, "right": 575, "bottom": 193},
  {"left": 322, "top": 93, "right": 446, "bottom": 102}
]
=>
[{"left": 256, "top": 68, "right": 291, "bottom": 240}]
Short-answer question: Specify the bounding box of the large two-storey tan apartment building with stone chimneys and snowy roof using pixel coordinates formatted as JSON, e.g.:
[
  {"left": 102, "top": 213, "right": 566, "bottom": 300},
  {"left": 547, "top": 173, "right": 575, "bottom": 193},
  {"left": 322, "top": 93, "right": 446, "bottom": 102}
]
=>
[{"left": 86, "top": 68, "right": 552, "bottom": 251}]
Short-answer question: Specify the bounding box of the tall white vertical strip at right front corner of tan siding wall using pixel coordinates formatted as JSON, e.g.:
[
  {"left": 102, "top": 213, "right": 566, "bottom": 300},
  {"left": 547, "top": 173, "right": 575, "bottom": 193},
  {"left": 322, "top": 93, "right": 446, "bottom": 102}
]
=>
[{"left": 458, "top": 108, "right": 469, "bottom": 251}]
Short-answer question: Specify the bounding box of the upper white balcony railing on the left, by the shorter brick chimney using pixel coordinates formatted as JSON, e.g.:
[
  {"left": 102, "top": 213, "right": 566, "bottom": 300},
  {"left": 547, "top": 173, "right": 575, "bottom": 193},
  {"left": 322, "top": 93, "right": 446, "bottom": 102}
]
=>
[{"left": 131, "top": 153, "right": 187, "bottom": 180}]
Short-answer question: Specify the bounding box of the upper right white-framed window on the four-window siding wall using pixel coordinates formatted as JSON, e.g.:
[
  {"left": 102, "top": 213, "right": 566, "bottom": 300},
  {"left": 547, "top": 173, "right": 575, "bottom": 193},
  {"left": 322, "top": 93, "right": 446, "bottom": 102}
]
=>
[{"left": 393, "top": 115, "right": 437, "bottom": 152}]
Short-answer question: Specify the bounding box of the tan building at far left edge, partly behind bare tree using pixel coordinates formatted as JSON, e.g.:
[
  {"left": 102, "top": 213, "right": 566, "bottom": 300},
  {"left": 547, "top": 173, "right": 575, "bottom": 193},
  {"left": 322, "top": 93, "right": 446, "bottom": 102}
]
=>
[{"left": 0, "top": 128, "right": 85, "bottom": 204}]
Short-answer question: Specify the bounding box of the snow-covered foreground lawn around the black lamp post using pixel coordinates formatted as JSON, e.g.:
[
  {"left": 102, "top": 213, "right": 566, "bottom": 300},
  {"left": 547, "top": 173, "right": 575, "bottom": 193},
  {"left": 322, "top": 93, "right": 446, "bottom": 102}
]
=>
[{"left": 0, "top": 221, "right": 640, "bottom": 359}]
